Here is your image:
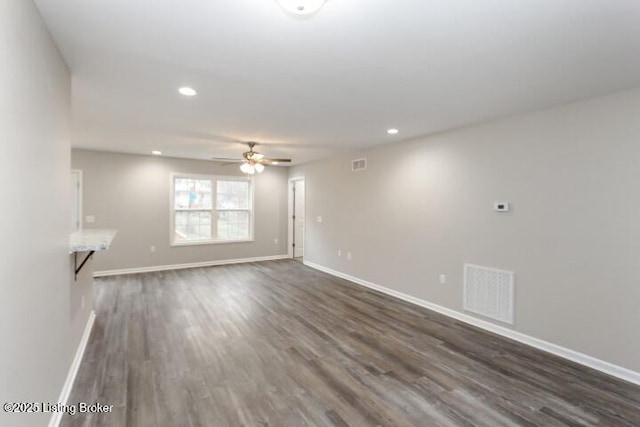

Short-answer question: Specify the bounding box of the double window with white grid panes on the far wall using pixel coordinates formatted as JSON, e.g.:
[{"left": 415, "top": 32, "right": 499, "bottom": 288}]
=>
[{"left": 171, "top": 174, "right": 253, "bottom": 245}]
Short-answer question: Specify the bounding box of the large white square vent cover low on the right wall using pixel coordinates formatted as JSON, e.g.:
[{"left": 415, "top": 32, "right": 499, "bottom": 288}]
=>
[{"left": 463, "top": 264, "right": 513, "bottom": 325}]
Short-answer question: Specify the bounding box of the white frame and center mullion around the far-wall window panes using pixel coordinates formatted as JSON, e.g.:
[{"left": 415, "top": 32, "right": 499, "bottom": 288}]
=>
[{"left": 169, "top": 172, "right": 255, "bottom": 246}]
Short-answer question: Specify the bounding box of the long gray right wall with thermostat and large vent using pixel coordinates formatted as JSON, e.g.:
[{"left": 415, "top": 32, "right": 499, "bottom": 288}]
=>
[{"left": 290, "top": 90, "right": 640, "bottom": 372}]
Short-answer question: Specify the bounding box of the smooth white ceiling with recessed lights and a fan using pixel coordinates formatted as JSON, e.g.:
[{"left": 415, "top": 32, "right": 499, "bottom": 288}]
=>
[{"left": 35, "top": 0, "right": 640, "bottom": 164}]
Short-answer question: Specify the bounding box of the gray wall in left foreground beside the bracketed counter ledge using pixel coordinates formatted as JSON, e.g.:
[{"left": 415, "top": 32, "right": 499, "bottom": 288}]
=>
[{"left": 0, "top": 0, "right": 91, "bottom": 426}]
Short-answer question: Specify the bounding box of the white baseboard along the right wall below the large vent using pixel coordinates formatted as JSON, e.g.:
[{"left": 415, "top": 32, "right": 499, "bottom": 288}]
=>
[{"left": 304, "top": 261, "right": 640, "bottom": 385}]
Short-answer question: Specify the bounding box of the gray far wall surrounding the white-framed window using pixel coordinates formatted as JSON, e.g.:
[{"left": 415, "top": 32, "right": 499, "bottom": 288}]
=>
[{"left": 72, "top": 150, "right": 287, "bottom": 271}]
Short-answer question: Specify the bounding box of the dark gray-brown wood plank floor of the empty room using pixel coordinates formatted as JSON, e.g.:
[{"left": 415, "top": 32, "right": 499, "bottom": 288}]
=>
[{"left": 62, "top": 260, "right": 640, "bottom": 427}]
